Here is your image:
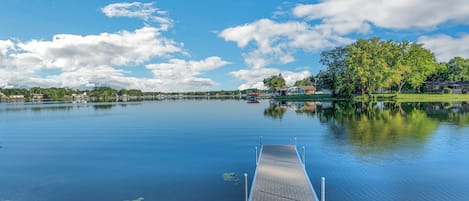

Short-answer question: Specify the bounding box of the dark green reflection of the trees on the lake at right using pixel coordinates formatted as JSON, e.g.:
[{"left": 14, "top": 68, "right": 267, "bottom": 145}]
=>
[{"left": 264, "top": 102, "right": 469, "bottom": 154}]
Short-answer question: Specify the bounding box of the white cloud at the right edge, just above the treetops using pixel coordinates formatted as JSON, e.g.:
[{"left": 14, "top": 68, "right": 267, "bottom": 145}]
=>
[{"left": 418, "top": 34, "right": 469, "bottom": 62}]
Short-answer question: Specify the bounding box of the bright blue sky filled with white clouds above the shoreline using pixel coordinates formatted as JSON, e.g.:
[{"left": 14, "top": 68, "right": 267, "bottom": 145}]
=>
[{"left": 0, "top": 0, "right": 469, "bottom": 92}]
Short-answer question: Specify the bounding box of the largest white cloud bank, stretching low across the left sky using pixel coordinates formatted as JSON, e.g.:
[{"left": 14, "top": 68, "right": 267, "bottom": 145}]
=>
[{"left": 0, "top": 26, "right": 229, "bottom": 91}]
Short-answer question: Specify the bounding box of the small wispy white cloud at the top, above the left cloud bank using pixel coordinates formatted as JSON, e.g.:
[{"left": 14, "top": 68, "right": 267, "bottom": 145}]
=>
[{"left": 101, "top": 2, "right": 173, "bottom": 30}]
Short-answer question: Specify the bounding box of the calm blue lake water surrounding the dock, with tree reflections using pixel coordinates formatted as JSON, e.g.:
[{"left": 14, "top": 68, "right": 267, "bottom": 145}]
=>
[{"left": 0, "top": 100, "right": 469, "bottom": 201}]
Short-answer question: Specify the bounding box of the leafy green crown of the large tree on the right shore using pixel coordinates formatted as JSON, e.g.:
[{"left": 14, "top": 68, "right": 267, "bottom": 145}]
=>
[{"left": 317, "top": 38, "right": 440, "bottom": 97}]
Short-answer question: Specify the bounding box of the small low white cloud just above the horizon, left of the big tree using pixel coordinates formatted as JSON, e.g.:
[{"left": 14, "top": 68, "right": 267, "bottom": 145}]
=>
[{"left": 230, "top": 68, "right": 311, "bottom": 90}]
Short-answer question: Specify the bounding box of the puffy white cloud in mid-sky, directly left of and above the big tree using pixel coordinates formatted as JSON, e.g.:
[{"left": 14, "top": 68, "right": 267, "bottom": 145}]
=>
[{"left": 218, "top": 19, "right": 350, "bottom": 68}]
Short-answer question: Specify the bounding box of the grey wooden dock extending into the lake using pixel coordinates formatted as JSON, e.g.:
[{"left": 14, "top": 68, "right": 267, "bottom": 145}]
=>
[{"left": 249, "top": 145, "right": 318, "bottom": 201}]
